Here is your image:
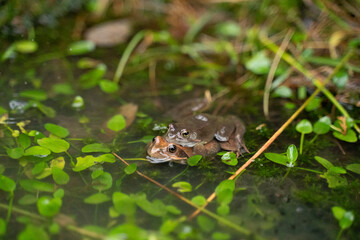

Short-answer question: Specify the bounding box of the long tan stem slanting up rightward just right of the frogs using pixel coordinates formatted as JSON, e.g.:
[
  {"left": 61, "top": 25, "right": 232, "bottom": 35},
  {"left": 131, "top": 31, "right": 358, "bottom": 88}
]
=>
[{"left": 188, "top": 44, "right": 353, "bottom": 219}]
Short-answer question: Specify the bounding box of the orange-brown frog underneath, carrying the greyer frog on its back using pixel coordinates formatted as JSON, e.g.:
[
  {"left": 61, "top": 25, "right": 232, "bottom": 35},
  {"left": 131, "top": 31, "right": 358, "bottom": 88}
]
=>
[{"left": 147, "top": 136, "right": 220, "bottom": 164}]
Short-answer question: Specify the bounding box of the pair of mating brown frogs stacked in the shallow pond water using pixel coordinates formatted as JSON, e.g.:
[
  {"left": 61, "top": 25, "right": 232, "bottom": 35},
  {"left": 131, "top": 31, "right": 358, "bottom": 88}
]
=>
[{"left": 147, "top": 113, "right": 249, "bottom": 164}]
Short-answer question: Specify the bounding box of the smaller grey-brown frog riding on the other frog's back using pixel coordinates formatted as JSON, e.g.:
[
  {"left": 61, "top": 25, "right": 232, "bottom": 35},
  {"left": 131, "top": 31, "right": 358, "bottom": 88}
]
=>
[{"left": 165, "top": 113, "right": 249, "bottom": 156}]
